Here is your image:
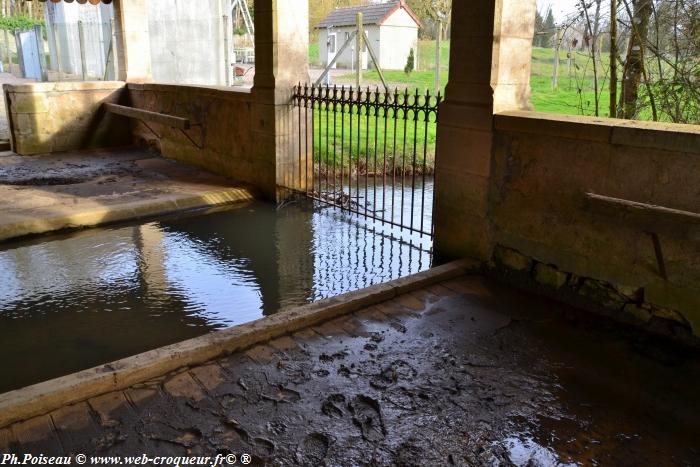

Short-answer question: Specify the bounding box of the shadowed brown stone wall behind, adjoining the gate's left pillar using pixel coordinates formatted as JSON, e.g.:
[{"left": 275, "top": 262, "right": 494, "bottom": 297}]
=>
[{"left": 128, "top": 83, "right": 260, "bottom": 191}]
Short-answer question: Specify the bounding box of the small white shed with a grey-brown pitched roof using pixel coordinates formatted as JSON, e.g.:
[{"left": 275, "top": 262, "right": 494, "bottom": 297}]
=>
[{"left": 316, "top": 0, "right": 421, "bottom": 70}]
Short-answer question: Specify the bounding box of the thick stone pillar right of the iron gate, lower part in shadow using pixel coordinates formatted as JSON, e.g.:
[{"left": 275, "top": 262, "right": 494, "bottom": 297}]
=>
[{"left": 435, "top": 0, "right": 536, "bottom": 260}]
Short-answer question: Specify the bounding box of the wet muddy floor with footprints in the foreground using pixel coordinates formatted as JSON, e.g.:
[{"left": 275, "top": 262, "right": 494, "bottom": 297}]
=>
[{"left": 0, "top": 276, "right": 700, "bottom": 466}]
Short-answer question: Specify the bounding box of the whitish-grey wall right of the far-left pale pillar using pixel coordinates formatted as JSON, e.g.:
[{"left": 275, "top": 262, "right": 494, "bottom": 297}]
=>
[{"left": 148, "top": 0, "right": 227, "bottom": 85}]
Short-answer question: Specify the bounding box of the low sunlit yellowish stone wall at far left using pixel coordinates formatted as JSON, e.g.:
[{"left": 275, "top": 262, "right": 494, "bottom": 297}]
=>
[{"left": 3, "top": 81, "right": 130, "bottom": 155}]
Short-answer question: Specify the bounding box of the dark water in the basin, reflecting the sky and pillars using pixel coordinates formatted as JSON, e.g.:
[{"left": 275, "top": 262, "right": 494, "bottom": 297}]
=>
[{"left": 0, "top": 199, "right": 431, "bottom": 392}]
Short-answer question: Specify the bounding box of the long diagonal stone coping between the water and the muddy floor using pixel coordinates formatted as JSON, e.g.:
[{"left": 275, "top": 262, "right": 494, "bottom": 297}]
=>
[{"left": 0, "top": 260, "right": 482, "bottom": 428}]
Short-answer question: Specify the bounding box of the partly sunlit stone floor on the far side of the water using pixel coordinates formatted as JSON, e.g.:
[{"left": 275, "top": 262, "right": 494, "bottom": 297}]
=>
[{"left": 0, "top": 149, "right": 252, "bottom": 239}]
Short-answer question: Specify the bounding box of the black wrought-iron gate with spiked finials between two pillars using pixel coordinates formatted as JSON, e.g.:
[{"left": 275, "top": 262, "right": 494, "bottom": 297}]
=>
[{"left": 293, "top": 85, "right": 442, "bottom": 237}]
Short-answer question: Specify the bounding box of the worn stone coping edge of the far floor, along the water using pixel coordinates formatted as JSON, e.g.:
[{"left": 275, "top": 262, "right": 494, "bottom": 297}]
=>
[{"left": 0, "top": 188, "right": 256, "bottom": 243}]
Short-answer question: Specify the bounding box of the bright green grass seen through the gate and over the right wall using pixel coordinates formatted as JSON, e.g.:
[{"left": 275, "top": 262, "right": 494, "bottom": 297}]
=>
[{"left": 309, "top": 41, "right": 660, "bottom": 173}]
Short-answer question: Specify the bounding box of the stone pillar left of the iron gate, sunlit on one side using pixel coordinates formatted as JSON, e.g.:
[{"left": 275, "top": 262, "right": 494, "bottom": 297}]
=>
[{"left": 253, "top": 0, "right": 309, "bottom": 199}]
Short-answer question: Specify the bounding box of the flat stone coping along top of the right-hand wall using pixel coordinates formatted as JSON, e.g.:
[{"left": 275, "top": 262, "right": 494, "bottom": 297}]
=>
[{"left": 494, "top": 111, "right": 700, "bottom": 154}]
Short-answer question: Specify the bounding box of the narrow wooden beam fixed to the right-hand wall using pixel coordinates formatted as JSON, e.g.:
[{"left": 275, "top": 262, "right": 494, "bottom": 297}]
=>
[{"left": 586, "top": 193, "right": 700, "bottom": 240}]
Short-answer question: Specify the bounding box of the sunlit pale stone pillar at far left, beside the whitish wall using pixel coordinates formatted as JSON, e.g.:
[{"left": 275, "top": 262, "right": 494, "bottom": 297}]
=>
[{"left": 114, "top": 0, "right": 152, "bottom": 83}]
